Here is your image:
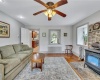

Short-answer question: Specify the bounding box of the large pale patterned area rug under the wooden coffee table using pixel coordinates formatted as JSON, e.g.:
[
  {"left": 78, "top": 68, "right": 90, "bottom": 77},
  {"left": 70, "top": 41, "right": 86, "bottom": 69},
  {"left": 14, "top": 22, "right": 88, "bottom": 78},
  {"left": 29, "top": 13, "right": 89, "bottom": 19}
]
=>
[{"left": 14, "top": 57, "right": 80, "bottom": 80}]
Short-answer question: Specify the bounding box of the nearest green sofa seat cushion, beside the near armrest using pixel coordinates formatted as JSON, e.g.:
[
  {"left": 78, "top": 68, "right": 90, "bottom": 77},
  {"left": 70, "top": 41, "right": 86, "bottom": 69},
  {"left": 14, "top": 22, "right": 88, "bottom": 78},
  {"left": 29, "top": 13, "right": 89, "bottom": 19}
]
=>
[{"left": 4, "top": 58, "right": 20, "bottom": 74}]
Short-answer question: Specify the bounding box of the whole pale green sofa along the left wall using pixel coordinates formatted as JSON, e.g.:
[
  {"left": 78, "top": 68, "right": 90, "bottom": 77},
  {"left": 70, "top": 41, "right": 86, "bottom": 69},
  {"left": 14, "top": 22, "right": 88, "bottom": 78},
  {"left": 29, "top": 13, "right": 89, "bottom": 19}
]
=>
[{"left": 0, "top": 44, "right": 33, "bottom": 80}]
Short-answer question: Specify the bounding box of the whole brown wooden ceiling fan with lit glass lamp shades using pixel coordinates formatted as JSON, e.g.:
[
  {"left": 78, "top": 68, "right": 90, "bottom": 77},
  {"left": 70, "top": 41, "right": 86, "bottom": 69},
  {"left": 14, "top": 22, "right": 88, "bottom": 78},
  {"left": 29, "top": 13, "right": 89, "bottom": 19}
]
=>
[{"left": 33, "top": 0, "right": 68, "bottom": 21}]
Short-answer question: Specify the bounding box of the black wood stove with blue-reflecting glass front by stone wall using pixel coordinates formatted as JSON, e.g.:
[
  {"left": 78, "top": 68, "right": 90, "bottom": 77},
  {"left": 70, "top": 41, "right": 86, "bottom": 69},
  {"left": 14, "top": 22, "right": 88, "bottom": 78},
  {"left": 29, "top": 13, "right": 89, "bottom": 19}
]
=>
[{"left": 84, "top": 49, "right": 100, "bottom": 74}]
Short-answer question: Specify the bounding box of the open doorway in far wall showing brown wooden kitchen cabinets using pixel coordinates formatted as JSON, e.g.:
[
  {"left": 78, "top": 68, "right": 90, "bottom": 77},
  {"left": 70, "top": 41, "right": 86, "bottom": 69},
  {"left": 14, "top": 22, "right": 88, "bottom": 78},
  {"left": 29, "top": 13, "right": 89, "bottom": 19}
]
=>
[{"left": 32, "top": 30, "right": 40, "bottom": 52}]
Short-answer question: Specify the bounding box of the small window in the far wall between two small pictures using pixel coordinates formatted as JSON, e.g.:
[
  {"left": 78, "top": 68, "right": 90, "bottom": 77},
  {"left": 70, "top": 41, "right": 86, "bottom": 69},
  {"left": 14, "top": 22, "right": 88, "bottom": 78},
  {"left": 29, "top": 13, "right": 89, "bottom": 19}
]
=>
[{"left": 49, "top": 30, "right": 61, "bottom": 44}]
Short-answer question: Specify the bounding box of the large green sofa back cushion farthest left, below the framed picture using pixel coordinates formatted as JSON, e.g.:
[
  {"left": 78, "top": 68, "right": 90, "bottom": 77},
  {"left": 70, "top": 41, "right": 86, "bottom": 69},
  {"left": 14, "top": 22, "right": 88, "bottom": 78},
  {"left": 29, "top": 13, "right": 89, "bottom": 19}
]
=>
[{"left": 0, "top": 45, "right": 15, "bottom": 59}]
